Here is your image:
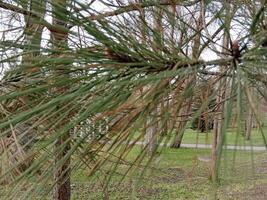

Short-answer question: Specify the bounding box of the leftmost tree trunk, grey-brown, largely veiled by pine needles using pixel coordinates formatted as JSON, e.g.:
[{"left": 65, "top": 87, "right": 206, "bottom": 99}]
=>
[{"left": 14, "top": 1, "right": 46, "bottom": 171}]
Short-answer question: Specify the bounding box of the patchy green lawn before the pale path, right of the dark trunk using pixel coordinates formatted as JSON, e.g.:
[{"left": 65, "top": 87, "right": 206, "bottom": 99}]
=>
[{"left": 72, "top": 146, "right": 267, "bottom": 200}]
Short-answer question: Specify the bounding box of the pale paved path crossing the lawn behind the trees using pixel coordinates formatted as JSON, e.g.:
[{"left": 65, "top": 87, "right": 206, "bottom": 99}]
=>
[{"left": 136, "top": 142, "right": 267, "bottom": 151}]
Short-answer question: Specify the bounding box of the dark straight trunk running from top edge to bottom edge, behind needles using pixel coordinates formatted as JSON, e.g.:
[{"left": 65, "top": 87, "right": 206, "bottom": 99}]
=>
[{"left": 51, "top": 0, "right": 71, "bottom": 200}]
